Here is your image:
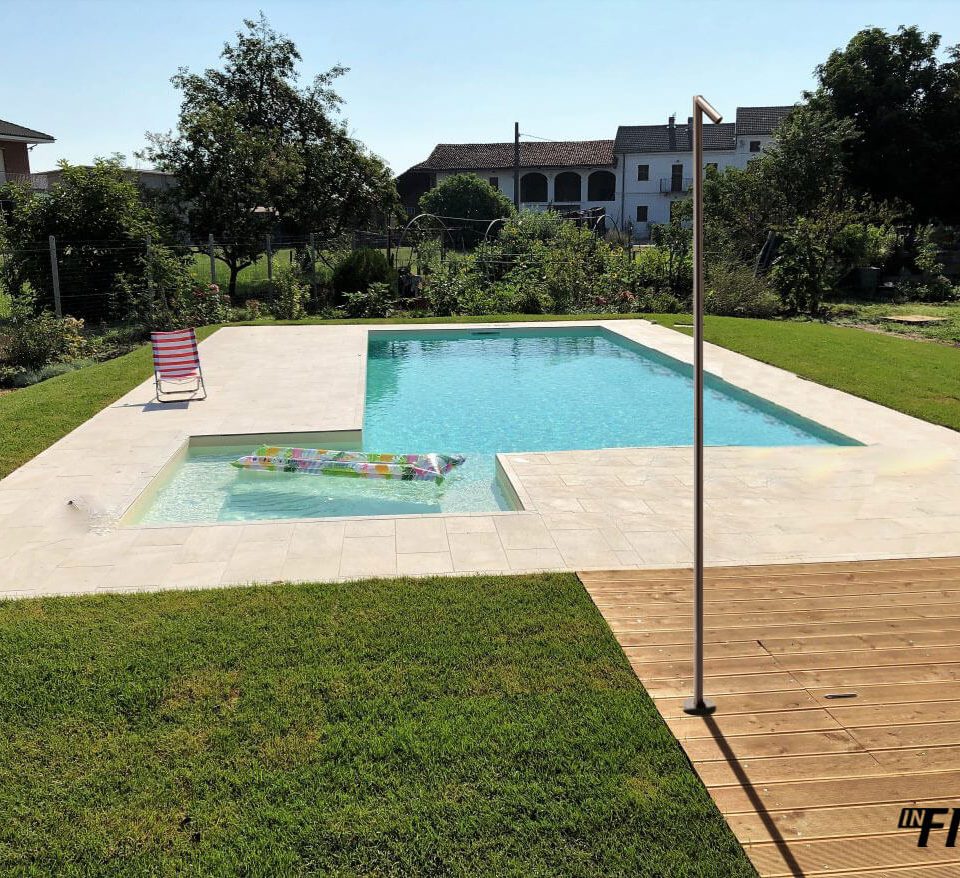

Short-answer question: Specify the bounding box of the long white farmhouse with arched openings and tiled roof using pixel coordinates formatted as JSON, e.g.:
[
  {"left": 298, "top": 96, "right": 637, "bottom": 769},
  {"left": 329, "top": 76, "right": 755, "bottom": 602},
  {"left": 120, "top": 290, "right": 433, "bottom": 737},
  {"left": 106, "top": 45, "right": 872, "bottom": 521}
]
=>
[{"left": 397, "top": 106, "right": 793, "bottom": 240}]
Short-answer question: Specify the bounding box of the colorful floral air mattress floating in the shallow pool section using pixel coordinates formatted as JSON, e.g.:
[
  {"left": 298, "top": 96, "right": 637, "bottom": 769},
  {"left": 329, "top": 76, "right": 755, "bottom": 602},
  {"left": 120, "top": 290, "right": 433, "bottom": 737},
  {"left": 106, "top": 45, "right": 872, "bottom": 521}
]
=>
[{"left": 231, "top": 445, "right": 465, "bottom": 485}]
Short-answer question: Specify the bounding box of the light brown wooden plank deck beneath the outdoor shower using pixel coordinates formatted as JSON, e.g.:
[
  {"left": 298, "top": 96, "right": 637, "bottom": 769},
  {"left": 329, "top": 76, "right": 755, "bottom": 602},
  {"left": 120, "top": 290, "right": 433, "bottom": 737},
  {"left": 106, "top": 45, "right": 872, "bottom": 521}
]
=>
[{"left": 580, "top": 558, "right": 960, "bottom": 878}]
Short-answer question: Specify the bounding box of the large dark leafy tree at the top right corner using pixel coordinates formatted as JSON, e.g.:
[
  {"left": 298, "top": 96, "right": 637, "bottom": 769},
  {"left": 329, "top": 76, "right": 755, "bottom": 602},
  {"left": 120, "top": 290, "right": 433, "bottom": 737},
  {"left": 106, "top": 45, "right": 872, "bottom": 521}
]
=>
[{"left": 809, "top": 27, "right": 960, "bottom": 222}]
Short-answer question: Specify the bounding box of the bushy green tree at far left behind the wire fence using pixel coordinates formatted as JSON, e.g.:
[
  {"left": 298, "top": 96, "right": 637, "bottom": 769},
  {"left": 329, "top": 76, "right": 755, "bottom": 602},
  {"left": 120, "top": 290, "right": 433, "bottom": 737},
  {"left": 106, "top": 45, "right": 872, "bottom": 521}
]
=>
[{"left": 2, "top": 156, "right": 167, "bottom": 319}]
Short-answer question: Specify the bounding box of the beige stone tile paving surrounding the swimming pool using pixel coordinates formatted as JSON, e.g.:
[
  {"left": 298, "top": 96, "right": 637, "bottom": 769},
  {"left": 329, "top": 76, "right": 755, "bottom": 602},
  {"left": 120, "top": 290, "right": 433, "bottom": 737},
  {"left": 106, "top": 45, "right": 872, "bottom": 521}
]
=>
[{"left": 0, "top": 320, "right": 960, "bottom": 596}]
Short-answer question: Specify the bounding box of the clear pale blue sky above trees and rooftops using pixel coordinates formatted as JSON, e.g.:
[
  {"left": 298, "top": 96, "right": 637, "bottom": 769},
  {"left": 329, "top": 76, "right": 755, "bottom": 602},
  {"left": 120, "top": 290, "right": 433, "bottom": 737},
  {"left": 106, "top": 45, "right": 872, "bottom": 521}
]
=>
[{"left": 0, "top": 0, "right": 960, "bottom": 172}]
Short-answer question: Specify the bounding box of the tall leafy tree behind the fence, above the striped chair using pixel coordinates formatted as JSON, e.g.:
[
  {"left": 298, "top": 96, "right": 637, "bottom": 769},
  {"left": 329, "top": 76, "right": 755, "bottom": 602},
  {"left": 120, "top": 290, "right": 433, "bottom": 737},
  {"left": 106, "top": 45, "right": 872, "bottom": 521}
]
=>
[{"left": 144, "top": 15, "right": 398, "bottom": 293}]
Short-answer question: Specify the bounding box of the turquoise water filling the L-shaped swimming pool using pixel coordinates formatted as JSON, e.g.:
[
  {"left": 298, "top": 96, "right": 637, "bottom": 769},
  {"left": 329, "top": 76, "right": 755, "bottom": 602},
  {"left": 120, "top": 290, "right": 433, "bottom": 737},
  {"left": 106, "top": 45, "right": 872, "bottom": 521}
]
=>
[{"left": 133, "top": 328, "right": 858, "bottom": 523}]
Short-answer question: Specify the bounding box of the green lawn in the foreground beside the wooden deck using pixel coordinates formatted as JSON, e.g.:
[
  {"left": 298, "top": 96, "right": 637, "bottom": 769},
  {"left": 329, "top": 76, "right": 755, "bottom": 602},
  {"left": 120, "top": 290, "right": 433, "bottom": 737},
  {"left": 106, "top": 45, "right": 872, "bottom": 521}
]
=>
[{"left": 0, "top": 575, "right": 754, "bottom": 878}]
